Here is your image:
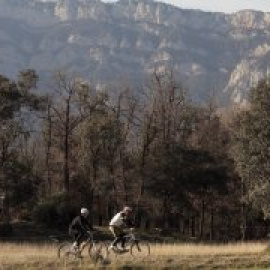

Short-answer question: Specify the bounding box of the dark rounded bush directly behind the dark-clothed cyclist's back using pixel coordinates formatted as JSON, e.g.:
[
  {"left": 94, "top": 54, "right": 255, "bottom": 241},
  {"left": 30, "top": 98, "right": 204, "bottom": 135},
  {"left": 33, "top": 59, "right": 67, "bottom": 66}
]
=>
[{"left": 34, "top": 194, "right": 79, "bottom": 229}]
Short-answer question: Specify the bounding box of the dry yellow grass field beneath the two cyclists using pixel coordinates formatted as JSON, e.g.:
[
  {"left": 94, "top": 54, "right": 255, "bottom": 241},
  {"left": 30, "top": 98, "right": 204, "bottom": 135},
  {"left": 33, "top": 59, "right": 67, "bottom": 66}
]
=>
[{"left": 0, "top": 243, "right": 270, "bottom": 270}]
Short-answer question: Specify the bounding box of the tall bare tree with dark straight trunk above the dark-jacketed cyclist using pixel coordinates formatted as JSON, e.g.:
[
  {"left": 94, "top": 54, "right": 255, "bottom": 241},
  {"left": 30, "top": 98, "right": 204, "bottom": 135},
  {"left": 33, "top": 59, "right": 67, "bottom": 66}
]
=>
[{"left": 49, "top": 71, "right": 94, "bottom": 194}]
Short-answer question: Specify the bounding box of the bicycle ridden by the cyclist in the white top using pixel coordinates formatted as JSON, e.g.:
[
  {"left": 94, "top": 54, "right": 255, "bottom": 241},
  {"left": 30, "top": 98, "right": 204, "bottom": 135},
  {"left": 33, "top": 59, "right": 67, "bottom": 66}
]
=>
[{"left": 107, "top": 228, "right": 150, "bottom": 257}]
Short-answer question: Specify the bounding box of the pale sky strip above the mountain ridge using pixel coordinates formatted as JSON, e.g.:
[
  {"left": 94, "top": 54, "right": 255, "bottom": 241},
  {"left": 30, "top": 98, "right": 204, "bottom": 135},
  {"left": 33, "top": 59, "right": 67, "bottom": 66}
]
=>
[{"left": 104, "top": 0, "right": 270, "bottom": 13}]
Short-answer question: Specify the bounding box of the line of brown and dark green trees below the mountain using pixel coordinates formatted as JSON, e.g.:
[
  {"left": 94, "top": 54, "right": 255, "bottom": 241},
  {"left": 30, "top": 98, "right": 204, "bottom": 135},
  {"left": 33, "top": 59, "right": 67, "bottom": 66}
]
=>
[{"left": 0, "top": 70, "right": 270, "bottom": 241}]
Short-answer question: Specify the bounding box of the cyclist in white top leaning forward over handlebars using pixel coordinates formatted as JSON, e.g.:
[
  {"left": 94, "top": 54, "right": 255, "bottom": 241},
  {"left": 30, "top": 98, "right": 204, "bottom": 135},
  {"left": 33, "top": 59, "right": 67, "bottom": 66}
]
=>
[{"left": 109, "top": 206, "right": 134, "bottom": 251}]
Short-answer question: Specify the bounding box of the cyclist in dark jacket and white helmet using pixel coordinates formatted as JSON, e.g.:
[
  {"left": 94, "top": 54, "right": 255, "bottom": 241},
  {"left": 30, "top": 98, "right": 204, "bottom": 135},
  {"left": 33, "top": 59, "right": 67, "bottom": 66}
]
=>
[{"left": 69, "top": 208, "right": 94, "bottom": 250}]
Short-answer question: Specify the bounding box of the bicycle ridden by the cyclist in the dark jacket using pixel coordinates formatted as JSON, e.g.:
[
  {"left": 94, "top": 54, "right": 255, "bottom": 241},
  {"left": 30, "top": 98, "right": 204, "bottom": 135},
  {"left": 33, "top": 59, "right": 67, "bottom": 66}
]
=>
[{"left": 57, "top": 232, "right": 108, "bottom": 263}]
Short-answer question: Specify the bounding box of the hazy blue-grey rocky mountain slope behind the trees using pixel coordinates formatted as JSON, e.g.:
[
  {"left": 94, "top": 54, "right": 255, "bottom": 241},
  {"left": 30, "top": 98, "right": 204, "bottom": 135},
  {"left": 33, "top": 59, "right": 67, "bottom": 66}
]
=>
[{"left": 0, "top": 0, "right": 270, "bottom": 104}]
